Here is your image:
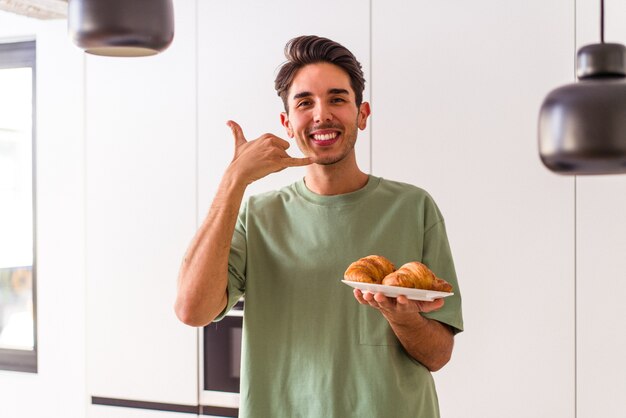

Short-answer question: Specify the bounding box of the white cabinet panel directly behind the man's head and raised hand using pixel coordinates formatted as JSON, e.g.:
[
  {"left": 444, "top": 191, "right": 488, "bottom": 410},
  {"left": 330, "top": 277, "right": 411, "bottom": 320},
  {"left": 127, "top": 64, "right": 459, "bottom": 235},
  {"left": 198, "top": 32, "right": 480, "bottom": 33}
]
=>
[{"left": 198, "top": 0, "right": 370, "bottom": 212}]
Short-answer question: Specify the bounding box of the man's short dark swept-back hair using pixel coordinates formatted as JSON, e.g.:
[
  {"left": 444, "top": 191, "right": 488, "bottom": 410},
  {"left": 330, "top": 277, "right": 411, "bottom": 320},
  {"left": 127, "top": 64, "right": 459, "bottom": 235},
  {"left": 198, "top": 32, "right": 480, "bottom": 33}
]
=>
[{"left": 274, "top": 35, "right": 365, "bottom": 111}]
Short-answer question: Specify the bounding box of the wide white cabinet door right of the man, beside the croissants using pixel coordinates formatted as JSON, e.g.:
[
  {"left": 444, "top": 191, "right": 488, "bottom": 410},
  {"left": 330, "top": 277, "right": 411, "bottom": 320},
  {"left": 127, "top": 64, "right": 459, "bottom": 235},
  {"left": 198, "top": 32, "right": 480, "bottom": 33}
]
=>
[{"left": 371, "top": 0, "right": 574, "bottom": 418}]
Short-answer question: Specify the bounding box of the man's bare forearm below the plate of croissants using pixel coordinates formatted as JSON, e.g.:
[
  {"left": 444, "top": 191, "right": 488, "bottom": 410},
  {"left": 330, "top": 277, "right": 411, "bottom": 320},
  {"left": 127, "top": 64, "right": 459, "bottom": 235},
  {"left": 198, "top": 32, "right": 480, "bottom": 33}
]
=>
[{"left": 389, "top": 314, "right": 454, "bottom": 372}]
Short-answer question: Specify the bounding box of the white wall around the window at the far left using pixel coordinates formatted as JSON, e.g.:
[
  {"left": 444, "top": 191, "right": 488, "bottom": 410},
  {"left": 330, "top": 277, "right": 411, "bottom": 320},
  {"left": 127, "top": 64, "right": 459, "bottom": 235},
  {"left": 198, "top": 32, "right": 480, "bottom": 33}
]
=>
[{"left": 0, "top": 12, "right": 86, "bottom": 418}]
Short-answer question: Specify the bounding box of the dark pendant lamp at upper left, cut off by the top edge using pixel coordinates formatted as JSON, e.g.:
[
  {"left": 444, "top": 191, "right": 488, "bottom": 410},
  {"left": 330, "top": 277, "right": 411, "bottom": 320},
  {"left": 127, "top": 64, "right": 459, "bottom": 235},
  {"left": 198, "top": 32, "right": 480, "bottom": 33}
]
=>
[{"left": 67, "top": 0, "right": 174, "bottom": 57}]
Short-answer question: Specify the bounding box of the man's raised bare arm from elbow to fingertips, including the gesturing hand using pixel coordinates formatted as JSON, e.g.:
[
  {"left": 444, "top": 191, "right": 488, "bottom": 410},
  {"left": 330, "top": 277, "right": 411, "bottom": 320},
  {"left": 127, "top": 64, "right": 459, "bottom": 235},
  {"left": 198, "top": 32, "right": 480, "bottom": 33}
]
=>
[{"left": 175, "top": 121, "right": 311, "bottom": 327}]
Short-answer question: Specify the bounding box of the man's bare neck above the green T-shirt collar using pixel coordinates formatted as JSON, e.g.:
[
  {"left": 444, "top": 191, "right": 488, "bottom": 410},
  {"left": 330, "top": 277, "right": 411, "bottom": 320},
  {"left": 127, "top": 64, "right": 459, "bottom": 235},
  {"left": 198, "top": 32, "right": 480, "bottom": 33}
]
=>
[{"left": 304, "top": 153, "right": 369, "bottom": 196}]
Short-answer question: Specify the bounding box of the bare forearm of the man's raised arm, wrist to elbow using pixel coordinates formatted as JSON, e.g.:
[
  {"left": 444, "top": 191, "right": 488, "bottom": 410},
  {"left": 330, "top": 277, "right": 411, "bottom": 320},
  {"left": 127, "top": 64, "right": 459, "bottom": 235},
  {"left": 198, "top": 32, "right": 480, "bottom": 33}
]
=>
[{"left": 175, "top": 170, "right": 246, "bottom": 326}]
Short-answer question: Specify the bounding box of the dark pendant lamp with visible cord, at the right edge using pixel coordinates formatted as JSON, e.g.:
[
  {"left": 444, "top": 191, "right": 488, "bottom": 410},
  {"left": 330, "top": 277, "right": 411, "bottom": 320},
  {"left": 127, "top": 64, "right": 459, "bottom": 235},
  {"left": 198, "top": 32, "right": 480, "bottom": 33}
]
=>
[{"left": 539, "top": 0, "right": 626, "bottom": 174}]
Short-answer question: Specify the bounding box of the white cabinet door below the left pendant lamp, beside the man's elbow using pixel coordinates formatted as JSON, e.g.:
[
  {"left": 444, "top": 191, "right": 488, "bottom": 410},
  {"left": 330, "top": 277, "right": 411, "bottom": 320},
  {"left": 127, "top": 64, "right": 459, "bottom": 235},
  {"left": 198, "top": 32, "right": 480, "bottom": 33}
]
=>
[{"left": 85, "top": 0, "right": 197, "bottom": 404}]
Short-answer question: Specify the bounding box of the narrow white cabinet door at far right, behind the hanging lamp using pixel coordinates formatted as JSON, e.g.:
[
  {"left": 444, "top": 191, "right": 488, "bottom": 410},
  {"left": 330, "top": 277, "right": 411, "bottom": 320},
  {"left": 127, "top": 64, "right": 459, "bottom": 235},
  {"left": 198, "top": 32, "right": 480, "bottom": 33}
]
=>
[{"left": 576, "top": 0, "right": 626, "bottom": 418}]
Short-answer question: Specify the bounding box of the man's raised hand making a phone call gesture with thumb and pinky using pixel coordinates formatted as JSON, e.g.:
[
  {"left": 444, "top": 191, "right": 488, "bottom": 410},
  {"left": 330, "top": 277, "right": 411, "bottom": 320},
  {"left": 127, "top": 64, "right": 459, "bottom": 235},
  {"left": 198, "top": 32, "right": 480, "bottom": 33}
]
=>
[{"left": 227, "top": 120, "right": 312, "bottom": 184}]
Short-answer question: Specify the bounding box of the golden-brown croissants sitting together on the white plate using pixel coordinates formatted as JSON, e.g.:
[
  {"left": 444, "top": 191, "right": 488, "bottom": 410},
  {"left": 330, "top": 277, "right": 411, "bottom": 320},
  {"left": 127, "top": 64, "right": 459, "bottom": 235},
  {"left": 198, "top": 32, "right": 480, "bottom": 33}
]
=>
[{"left": 344, "top": 255, "right": 452, "bottom": 292}]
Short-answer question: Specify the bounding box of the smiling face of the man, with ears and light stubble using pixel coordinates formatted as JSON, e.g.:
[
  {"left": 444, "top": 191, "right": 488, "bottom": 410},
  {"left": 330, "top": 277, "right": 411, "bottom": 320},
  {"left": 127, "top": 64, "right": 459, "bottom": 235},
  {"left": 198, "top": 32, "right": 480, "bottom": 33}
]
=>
[{"left": 281, "top": 63, "right": 370, "bottom": 165}]
